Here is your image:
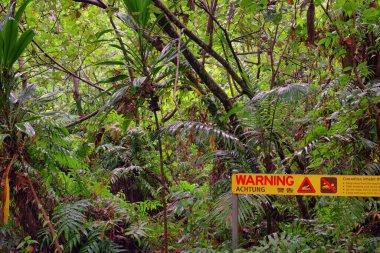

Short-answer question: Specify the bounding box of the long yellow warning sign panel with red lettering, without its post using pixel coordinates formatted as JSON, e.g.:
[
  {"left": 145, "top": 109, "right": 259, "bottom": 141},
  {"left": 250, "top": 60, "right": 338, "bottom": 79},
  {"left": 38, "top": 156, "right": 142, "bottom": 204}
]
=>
[{"left": 232, "top": 173, "right": 380, "bottom": 197}]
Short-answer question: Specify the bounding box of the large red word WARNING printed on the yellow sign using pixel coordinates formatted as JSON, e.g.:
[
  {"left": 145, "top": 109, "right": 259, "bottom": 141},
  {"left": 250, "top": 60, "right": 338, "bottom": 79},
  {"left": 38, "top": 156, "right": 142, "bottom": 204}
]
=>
[{"left": 236, "top": 174, "right": 294, "bottom": 186}]
